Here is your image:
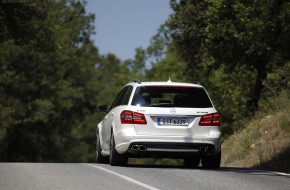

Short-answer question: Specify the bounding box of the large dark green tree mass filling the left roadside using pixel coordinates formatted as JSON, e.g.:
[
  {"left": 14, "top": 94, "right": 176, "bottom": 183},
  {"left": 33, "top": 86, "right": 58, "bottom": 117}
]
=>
[{"left": 0, "top": 0, "right": 99, "bottom": 162}]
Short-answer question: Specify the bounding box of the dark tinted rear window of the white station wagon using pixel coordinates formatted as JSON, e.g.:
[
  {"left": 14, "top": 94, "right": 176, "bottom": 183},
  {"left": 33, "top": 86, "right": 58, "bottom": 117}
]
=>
[{"left": 132, "top": 86, "right": 212, "bottom": 108}]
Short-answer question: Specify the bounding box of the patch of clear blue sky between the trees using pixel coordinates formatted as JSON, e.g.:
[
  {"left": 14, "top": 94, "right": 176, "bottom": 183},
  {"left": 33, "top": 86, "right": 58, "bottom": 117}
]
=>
[{"left": 86, "top": 0, "right": 173, "bottom": 61}]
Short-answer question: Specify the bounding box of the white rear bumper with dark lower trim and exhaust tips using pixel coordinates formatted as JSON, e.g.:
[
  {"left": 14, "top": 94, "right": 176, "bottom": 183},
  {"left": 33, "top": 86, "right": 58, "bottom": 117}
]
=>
[{"left": 115, "top": 127, "right": 221, "bottom": 158}]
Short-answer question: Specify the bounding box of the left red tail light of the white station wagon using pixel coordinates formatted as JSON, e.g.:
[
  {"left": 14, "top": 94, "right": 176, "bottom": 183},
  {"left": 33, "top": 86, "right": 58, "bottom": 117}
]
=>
[{"left": 120, "top": 110, "right": 147, "bottom": 125}]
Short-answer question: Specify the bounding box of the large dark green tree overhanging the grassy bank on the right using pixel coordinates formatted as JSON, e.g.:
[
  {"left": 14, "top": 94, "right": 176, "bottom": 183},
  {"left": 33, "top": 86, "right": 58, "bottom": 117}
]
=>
[{"left": 167, "top": 0, "right": 290, "bottom": 132}]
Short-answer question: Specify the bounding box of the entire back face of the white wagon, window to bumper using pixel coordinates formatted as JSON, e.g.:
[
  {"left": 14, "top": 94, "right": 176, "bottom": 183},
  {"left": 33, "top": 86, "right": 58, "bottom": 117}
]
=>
[{"left": 116, "top": 82, "right": 221, "bottom": 158}]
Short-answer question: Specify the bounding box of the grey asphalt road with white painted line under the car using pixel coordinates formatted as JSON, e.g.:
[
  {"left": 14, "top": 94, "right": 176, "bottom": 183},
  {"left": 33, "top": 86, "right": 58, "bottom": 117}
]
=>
[{"left": 0, "top": 163, "right": 290, "bottom": 190}]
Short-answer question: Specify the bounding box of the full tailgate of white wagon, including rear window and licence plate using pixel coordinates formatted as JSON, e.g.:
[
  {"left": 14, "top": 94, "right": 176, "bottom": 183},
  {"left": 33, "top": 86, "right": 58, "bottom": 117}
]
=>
[{"left": 130, "top": 84, "right": 216, "bottom": 138}]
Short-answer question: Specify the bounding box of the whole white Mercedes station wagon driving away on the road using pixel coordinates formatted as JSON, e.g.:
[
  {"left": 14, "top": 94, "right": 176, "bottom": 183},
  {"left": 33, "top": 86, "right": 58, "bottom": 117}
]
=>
[{"left": 96, "top": 80, "right": 221, "bottom": 168}]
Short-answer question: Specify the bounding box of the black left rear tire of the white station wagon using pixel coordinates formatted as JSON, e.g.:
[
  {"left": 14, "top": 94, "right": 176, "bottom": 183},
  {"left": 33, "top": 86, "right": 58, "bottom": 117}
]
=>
[{"left": 110, "top": 134, "right": 128, "bottom": 166}]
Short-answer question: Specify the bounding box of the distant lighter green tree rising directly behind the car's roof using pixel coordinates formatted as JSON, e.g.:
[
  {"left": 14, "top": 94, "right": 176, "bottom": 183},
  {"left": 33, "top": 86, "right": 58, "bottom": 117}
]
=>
[{"left": 125, "top": 24, "right": 189, "bottom": 82}]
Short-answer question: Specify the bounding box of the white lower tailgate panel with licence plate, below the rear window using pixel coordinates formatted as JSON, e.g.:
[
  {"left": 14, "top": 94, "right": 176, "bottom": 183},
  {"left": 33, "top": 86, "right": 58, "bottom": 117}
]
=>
[{"left": 131, "top": 107, "right": 214, "bottom": 138}]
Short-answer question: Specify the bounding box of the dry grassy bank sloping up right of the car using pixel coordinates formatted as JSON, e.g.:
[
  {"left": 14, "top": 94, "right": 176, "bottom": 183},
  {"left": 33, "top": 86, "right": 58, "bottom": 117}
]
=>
[{"left": 222, "top": 92, "right": 290, "bottom": 172}]
